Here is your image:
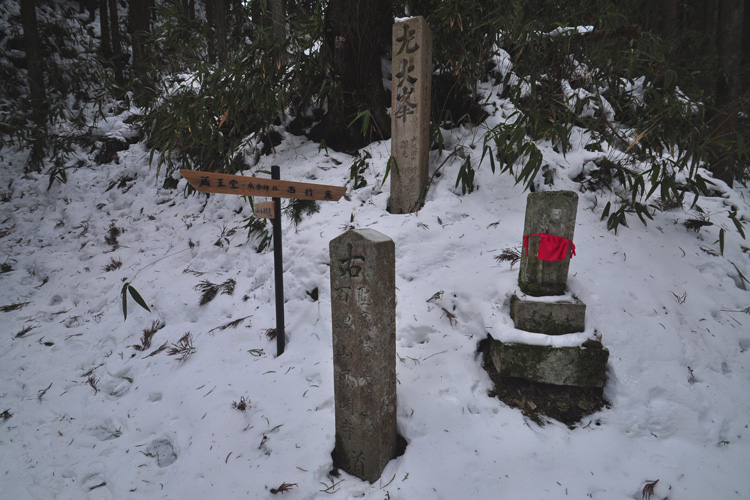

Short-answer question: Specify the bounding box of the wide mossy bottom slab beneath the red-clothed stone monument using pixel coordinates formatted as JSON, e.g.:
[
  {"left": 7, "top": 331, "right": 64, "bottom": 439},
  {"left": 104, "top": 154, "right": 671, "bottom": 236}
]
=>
[{"left": 490, "top": 339, "right": 609, "bottom": 387}]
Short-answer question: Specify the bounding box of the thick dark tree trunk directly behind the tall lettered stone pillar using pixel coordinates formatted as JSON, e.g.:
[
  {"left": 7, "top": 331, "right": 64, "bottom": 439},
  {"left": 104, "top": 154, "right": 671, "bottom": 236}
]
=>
[{"left": 312, "top": 0, "right": 393, "bottom": 151}]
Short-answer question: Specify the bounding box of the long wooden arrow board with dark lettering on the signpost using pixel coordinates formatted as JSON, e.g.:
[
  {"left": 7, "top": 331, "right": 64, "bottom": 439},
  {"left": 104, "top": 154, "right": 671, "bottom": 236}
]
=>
[{"left": 180, "top": 170, "right": 346, "bottom": 201}]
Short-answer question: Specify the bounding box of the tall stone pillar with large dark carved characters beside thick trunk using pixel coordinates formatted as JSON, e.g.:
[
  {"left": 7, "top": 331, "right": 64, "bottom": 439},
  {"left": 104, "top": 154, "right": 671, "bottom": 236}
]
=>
[{"left": 389, "top": 16, "right": 432, "bottom": 214}]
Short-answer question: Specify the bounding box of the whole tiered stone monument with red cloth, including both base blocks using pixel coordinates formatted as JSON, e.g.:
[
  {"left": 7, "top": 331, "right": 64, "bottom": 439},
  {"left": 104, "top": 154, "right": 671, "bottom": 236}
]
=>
[{"left": 490, "top": 191, "right": 609, "bottom": 396}]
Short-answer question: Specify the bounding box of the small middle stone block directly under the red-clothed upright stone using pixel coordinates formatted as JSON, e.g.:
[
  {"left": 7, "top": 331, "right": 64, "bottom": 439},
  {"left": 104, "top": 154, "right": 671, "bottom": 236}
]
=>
[{"left": 510, "top": 295, "right": 586, "bottom": 335}]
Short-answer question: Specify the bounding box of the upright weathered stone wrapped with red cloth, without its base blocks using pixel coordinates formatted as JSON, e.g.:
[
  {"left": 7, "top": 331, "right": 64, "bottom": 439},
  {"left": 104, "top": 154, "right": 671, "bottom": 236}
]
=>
[{"left": 518, "top": 191, "right": 578, "bottom": 297}]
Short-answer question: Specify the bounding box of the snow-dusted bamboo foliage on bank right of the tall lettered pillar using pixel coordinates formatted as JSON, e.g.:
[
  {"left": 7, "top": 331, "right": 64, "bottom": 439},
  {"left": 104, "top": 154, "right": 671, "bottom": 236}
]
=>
[{"left": 428, "top": 0, "right": 748, "bottom": 240}]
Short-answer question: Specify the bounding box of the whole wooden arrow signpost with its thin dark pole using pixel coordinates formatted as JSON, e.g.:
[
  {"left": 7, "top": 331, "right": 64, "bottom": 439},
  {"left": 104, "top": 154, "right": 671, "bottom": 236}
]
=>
[{"left": 180, "top": 165, "right": 346, "bottom": 356}]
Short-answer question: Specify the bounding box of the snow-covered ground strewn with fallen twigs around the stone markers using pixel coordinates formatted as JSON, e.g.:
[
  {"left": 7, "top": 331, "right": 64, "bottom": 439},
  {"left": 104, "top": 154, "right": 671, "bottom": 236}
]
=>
[{"left": 0, "top": 90, "right": 750, "bottom": 500}]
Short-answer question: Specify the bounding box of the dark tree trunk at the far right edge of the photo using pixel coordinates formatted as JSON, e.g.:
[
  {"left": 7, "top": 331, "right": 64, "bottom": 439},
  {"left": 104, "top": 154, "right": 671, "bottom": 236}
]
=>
[{"left": 710, "top": 0, "right": 744, "bottom": 186}]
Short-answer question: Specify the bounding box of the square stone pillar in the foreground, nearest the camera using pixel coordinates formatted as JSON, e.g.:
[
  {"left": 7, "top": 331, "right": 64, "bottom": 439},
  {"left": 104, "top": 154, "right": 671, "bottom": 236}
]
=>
[{"left": 329, "top": 229, "right": 398, "bottom": 483}]
